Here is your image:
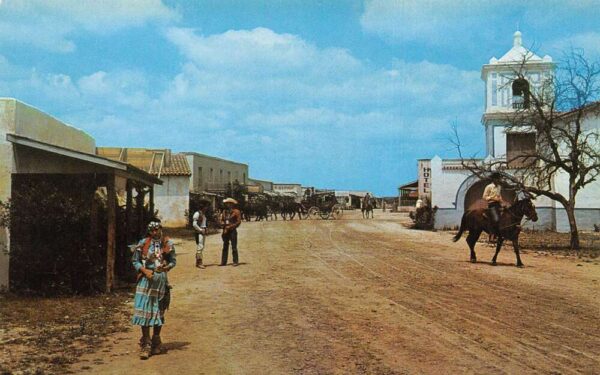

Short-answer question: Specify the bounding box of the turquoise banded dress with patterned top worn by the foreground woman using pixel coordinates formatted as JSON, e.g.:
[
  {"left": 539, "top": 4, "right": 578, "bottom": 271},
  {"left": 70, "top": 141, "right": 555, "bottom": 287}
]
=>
[{"left": 131, "top": 238, "right": 177, "bottom": 326}]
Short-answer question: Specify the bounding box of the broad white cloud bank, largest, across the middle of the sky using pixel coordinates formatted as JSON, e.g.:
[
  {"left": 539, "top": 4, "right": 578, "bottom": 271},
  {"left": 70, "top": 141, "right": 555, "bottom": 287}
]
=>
[{"left": 0, "top": 29, "right": 483, "bottom": 191}]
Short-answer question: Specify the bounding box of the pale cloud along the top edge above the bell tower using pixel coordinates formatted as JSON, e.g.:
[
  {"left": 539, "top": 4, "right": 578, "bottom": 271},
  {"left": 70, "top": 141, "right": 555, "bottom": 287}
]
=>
[{"left": 360, "top": 0, "right": 600, "bottom": 47}]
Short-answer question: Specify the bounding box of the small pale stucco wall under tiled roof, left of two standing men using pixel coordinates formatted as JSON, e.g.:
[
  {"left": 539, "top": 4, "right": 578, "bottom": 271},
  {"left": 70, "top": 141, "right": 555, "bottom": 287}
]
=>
[{"left": 154, "top": 176, "right": 190, "bottom": 228}]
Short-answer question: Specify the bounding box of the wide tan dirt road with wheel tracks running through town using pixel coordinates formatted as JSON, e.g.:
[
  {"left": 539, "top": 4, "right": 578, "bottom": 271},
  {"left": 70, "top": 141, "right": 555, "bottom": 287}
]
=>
[{"left": 79, "top": 212, "right": 600, "bottom": 375}]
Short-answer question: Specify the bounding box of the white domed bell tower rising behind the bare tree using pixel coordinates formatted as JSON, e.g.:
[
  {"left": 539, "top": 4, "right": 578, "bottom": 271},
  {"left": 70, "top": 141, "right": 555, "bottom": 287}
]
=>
[{"left": 481, "top": 31, "right": 555, "bottom": 158}]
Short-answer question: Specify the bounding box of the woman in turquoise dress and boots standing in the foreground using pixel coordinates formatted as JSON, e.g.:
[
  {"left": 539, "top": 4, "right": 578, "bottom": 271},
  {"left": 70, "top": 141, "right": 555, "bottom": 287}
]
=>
[{"left": 132, "top": 222, "right": 177, "bottom": 359}]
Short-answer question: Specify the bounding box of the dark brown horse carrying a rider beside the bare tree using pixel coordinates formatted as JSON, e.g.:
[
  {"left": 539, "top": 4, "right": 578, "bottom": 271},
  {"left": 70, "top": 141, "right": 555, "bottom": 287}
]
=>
[{"left": 453, "top": 197, "right": 538, "bottom": 267}]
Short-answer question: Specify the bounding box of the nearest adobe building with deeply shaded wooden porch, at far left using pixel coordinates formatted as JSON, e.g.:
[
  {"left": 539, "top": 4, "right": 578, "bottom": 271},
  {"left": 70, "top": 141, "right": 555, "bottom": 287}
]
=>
[{"left": 0, "top": 98, "right": 161, "bottom": 291}]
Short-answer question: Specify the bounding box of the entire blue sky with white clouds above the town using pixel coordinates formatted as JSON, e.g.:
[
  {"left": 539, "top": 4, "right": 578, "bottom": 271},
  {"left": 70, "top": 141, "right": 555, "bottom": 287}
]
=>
[{"left": 0, "top": 0, "right": 600, "bottom": 196}]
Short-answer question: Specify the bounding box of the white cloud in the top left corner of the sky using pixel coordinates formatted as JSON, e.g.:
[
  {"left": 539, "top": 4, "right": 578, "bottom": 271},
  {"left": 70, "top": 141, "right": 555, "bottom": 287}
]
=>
[{"left": 0, "top": 0, "right": 180, "bottom": 53}]
